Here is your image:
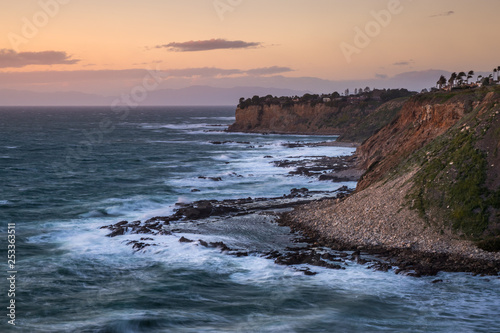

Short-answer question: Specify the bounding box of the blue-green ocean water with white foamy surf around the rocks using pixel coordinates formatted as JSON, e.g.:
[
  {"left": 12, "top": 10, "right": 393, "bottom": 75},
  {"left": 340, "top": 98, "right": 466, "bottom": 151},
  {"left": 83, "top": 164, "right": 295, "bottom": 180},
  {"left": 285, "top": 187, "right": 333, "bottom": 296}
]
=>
[{"left": 0, "top": 107, "right": 500, "bottom": 332}]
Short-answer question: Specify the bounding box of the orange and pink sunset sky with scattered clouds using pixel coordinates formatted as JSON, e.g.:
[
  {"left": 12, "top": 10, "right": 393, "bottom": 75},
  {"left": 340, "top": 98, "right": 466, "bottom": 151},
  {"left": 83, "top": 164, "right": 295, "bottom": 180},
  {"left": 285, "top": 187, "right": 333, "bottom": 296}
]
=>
[{"left": 0, "top": 0, "right": 500, "bottom": 104}]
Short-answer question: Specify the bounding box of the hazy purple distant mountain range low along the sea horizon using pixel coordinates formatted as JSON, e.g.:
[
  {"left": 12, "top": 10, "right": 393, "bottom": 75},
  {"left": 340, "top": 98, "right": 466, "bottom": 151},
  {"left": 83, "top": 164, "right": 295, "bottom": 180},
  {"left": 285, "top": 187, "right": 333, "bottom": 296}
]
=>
[{"left": 0, "top": 86, "right": 310, "bottom": 107}]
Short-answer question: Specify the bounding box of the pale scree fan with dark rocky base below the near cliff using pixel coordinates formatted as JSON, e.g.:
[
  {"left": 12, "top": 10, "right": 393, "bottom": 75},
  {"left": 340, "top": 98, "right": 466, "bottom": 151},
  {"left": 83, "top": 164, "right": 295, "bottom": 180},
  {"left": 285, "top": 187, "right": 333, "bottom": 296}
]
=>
[{"left": 279, "top": 173, "right": 500, "bottom": 276}]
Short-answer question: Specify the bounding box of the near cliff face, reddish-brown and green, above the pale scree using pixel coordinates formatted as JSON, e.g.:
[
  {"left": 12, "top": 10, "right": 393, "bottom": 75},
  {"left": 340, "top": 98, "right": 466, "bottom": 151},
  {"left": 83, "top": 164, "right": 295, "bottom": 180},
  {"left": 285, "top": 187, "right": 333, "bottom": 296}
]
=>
[{"left": 356, "top": 87, "right": 500, "bottom": 250}]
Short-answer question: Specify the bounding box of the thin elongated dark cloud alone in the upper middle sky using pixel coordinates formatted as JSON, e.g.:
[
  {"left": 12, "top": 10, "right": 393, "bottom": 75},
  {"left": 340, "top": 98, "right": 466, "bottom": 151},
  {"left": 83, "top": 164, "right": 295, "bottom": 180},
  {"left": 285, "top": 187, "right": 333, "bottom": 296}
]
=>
[{"left": 155, "top": 38, "right": 262, "bottom": 52}]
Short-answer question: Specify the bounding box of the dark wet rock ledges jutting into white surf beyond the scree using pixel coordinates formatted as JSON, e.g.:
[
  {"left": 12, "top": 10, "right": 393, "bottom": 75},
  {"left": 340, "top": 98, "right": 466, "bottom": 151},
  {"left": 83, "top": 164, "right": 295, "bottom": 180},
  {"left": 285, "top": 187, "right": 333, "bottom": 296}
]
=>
[{"left": 101, "top": 187, "right": 376, "bottom": 275}]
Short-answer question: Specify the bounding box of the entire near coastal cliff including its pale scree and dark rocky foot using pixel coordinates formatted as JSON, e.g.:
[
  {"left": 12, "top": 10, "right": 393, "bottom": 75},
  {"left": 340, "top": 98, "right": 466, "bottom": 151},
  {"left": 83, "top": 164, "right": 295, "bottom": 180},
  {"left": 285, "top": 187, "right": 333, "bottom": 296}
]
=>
[{"left": 284, "top": 87, "right": 500, "bottom": 274}]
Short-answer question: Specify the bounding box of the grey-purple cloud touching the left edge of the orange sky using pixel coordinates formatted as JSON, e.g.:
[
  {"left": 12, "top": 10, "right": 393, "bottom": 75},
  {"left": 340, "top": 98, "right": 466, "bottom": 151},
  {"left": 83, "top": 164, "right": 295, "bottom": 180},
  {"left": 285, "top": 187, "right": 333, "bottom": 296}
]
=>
[{"left": 0, "top": 49, "right": 80, "bottom": 68}]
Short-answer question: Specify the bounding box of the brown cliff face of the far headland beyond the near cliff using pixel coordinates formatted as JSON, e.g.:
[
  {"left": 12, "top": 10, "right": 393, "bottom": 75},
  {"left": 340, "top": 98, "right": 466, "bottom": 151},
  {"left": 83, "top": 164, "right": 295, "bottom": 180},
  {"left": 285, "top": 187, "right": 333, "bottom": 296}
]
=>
[{"left": 228, "top": 99, "right": 404, "bottom": 142}]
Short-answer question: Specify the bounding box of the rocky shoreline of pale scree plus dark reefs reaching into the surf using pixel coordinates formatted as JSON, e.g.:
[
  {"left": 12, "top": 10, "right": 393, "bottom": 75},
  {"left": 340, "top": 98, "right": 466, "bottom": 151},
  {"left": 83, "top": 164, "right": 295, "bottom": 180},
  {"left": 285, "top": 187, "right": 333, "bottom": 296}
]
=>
[{"left": 102, "top": 150, "right": 500, "bottom": 277}]
